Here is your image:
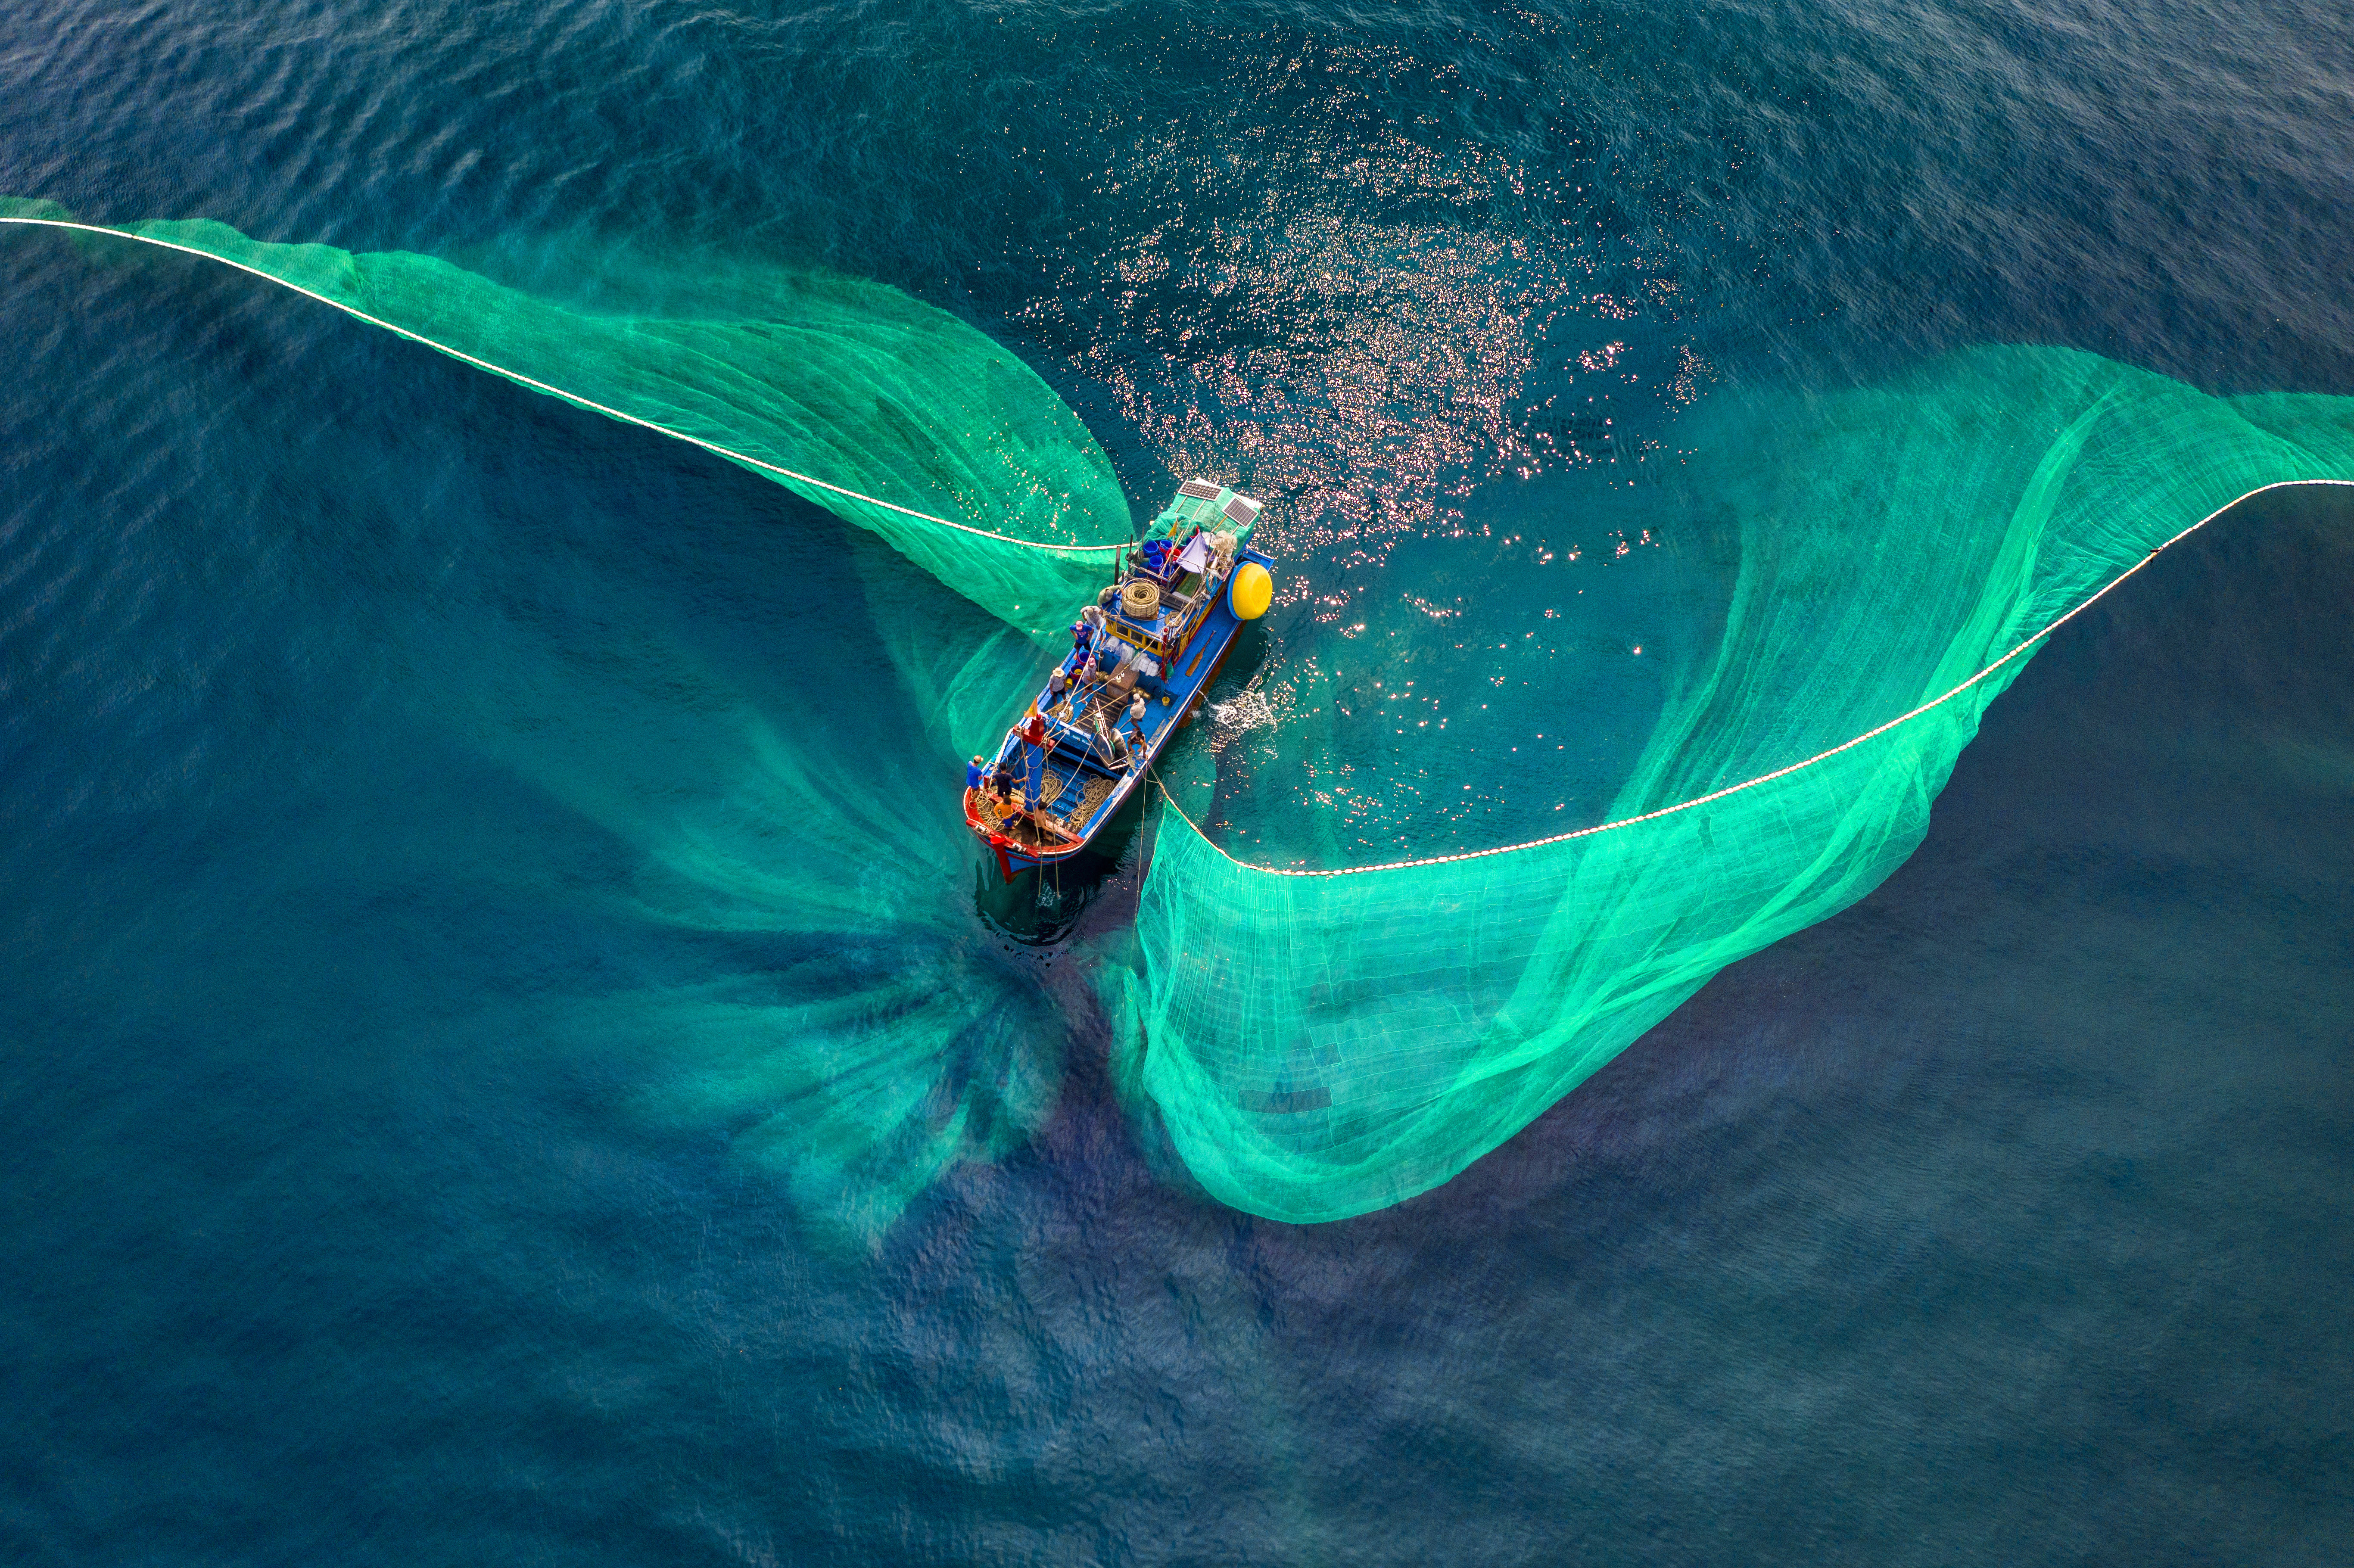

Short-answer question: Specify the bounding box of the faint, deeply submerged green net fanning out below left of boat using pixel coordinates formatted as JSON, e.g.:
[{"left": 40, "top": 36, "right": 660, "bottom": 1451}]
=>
[{"left": 468, "top": 555, "right": 1066, "bottom": 1245}]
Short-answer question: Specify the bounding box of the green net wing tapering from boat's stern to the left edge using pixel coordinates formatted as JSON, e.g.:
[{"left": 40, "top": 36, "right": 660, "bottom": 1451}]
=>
[{"left": 0, "top": 198, "right": 1130, "bottom": 636}]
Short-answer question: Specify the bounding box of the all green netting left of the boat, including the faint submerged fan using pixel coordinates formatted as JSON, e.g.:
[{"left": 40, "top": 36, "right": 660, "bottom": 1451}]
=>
[{"left": 0, "top": 202, "right": 1130, "bottom": 1241}]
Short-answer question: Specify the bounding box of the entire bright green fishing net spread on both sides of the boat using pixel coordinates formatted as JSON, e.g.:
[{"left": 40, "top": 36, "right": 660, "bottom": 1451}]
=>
[{"left": 14, "top": 202, "right": 2354, "bottom": 1222}]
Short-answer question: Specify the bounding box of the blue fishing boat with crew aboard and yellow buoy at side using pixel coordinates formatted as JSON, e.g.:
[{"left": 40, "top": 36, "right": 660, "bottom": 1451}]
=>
[{"left": 965, "top": 480, "right": 1276, "bottom": 880}]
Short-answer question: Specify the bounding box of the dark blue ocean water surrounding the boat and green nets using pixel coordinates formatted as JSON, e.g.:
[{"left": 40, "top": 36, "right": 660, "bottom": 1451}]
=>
[{"left": 0, "top": 0, "right": 2354, "bottom": 1566}]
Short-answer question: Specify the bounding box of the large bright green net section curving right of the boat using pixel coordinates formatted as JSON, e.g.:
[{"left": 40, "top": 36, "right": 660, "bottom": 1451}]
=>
[{"left": 1113, "top": 348, "right": 2354, "bottom": 1222}]
